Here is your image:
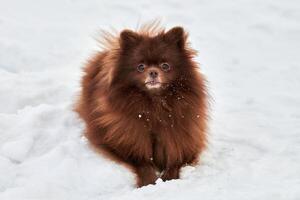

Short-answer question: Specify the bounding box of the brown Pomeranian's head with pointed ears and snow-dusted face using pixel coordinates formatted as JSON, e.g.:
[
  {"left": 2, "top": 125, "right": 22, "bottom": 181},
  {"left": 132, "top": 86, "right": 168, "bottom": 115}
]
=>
[{"left": 118, "top": 27, "right": 189, "bottom": 92}]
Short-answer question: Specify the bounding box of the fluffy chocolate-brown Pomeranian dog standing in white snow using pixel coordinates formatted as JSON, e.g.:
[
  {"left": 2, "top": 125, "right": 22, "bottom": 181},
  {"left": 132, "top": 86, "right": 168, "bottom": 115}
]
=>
[{"left": 76, "top": 24, "right": 207, "bottom": 187}]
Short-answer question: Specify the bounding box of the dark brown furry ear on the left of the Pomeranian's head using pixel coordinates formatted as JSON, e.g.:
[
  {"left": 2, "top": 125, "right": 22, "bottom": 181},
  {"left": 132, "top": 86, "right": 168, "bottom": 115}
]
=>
[{"left": 120, "top": 30, "right": 141, "bottom": 49}]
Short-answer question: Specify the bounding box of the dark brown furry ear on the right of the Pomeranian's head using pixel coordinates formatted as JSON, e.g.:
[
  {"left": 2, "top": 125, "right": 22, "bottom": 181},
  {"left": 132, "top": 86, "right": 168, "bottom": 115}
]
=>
[{"left": 164, "top": 26, "right": 186, "bottom": 49}]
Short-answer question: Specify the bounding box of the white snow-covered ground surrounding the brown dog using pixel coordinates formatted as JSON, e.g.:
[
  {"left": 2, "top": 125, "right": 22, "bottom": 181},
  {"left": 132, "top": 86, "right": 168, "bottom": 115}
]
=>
[{"left": 0, "top": 0, "right": 300, "bottom": 200}]
